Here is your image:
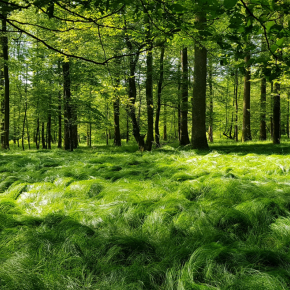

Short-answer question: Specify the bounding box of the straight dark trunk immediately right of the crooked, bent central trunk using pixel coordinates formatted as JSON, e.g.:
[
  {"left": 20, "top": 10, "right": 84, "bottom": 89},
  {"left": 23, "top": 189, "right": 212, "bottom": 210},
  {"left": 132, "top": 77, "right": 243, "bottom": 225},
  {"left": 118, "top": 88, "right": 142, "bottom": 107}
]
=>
[{"left": 145, "top": 25, "right": 154, "bottom": 151}]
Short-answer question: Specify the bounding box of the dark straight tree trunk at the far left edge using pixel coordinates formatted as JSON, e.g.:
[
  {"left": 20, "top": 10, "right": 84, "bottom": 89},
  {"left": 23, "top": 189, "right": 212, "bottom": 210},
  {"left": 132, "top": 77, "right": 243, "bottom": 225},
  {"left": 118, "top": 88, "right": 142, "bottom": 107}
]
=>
[{"left": 2, "top": 15, "right": 10, "bottom": 149}]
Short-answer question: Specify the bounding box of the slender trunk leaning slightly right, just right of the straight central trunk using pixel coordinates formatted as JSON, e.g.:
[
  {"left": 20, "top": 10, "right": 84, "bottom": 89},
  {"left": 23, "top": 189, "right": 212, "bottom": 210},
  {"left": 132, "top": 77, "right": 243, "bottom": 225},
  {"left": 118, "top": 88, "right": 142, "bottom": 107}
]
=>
[{"left": 155, "top": 46, "right": 166, "bottom": 147}]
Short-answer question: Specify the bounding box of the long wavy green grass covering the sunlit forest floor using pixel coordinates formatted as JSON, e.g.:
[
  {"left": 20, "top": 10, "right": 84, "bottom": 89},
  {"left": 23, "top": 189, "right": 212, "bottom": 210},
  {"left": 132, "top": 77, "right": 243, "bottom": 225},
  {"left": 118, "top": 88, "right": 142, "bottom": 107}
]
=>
[{"left": 0, "top": 142, "right": 290, "bottom": 290}]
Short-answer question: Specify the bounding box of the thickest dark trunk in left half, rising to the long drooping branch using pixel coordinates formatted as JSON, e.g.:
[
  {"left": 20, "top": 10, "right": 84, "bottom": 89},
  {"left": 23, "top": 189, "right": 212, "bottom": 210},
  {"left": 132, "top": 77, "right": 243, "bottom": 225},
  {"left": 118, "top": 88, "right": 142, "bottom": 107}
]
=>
[{"left": 62, "top": 62, "right": 73, "bottom": 151}]
